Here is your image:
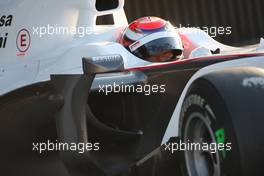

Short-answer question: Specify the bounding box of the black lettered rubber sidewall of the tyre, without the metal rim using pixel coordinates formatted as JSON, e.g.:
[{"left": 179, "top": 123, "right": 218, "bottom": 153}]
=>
[{"left": 180, "top": 81, "right": 241, "bottom": 176}]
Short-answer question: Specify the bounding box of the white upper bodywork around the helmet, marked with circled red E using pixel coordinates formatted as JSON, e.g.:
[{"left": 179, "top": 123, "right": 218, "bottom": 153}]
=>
[{"left": 0, "top": 0, "right": 243, "bottom": 95}]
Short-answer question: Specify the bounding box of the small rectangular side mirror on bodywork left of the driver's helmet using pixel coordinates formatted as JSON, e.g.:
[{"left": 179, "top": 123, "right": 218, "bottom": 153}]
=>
[{"left": 82, "top": 55, "right": 124, "bottom": 74}]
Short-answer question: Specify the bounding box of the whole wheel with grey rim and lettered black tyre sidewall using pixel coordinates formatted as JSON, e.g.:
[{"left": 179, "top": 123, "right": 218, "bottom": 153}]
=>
[{"left": 180, "top": 80, "right": 242, "bottom": 176}]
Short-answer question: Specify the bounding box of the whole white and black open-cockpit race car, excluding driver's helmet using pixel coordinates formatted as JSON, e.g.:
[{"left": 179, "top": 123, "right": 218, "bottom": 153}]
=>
[{"left": 0, "top": 0, "right": 264, "bottom": 176}]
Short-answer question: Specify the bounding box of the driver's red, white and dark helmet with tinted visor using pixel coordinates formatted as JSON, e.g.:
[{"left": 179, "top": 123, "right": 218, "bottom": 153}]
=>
[{"left": 119, "top": 17, "right": 183, "bottom": 62}]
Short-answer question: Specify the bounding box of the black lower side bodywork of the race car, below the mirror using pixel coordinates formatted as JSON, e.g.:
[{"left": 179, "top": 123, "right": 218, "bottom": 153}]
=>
[{"left": 0, "top": 56, "right": 262, "bottom": 176}]
